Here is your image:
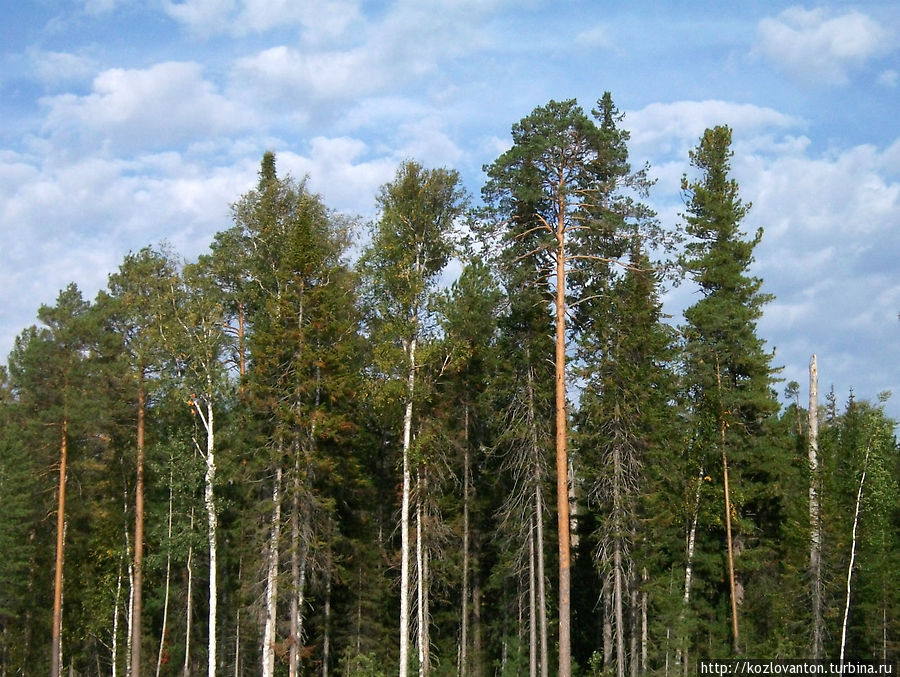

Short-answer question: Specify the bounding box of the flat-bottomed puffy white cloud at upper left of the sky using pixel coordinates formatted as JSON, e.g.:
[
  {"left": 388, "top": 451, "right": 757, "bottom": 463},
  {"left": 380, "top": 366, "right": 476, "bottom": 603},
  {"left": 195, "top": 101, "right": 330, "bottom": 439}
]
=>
[{"left": 42, "top": 62, "right": 254, "bottom": 151}]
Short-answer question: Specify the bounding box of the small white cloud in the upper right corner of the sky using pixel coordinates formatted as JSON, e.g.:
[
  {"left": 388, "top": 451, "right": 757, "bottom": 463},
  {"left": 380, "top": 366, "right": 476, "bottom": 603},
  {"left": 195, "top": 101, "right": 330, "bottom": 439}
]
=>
[{"left": 755, "top": 7, "right": 897, "bottom": 84}]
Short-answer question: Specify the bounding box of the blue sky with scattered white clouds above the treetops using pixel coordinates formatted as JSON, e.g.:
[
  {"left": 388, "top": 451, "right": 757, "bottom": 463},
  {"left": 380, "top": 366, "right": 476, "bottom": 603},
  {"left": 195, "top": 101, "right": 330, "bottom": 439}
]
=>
[{"left": 0, "top": 0, "right": 900, "bottom": 418}]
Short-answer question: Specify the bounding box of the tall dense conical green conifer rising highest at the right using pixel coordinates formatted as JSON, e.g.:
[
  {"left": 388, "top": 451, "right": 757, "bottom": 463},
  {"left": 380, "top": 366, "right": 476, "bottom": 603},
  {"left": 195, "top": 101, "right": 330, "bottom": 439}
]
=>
[{"left": 682, "top": 126, "right": 778, "bottom": 653}]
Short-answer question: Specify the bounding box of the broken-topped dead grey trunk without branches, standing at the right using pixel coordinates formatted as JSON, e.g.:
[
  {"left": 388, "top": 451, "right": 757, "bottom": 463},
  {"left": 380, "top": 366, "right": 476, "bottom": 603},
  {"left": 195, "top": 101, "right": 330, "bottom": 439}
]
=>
[{"left": 808, "top": 355, "right": 825, "bottom": 659}]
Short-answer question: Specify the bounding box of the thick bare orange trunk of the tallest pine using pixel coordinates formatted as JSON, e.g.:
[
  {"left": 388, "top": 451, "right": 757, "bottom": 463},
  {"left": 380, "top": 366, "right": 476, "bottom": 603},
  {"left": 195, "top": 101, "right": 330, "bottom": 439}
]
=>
[{"left": 556, "top": 191, "right": 572, "bottom": 677}]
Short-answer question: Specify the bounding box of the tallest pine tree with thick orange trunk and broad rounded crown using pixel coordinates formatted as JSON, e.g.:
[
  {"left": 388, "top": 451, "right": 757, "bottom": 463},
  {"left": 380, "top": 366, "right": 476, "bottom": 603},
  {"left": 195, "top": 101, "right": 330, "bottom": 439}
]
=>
[{"left": 483, "top": 93, "right": 672, "bottom": 677}]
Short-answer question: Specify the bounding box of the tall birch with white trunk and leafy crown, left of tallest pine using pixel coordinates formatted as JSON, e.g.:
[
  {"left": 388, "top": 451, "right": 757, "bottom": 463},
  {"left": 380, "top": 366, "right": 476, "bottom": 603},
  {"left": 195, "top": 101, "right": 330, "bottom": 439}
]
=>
[{"left": 362, "top": 162, "right": 466, "bottom": 677}]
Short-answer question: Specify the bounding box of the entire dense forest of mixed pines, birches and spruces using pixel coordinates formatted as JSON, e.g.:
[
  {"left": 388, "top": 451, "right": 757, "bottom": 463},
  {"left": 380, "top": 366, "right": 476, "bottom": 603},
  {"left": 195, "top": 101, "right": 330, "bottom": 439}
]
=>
[{"left": 0, "top": 93, "right": 900, "bottom": 677}]
